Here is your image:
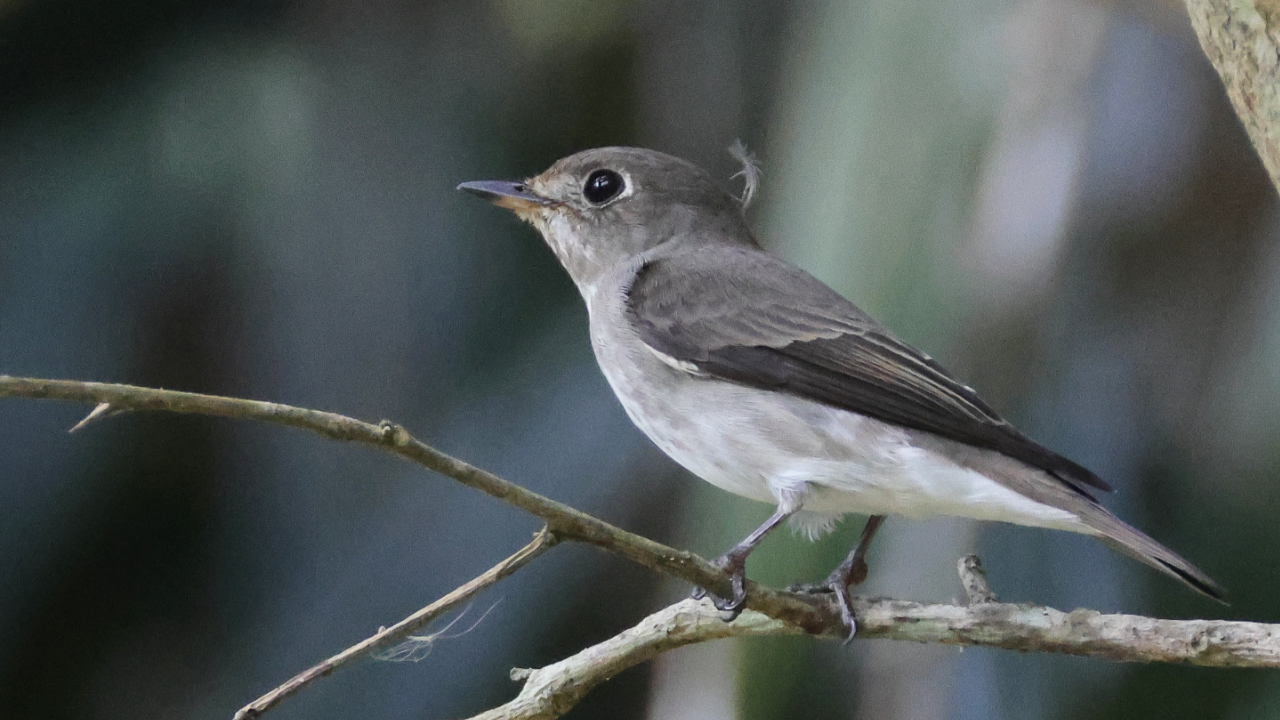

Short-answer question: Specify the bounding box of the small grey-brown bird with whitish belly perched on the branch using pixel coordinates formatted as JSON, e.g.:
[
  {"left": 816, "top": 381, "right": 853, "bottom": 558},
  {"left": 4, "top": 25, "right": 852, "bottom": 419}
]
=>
[{"left": 458, "top": 147, "right": 1222, "bottom": 629}]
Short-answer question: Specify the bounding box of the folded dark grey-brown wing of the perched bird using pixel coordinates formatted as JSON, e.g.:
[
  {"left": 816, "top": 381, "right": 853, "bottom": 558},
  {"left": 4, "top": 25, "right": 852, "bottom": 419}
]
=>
[{"left": 627, "top": 246, "right": 1111, "bottom": 500}]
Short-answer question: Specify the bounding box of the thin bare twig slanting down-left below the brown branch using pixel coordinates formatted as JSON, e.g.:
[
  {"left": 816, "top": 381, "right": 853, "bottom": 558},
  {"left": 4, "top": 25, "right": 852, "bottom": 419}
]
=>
[{"left": 234, "top": 528, "right": 556, "bottom": 720}]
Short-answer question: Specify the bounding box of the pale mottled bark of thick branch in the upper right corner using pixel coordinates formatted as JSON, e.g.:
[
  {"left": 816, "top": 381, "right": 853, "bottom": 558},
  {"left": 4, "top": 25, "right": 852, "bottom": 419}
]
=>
[{"left": 1185, "top": 0, "right": 1280, "bottom": 190}]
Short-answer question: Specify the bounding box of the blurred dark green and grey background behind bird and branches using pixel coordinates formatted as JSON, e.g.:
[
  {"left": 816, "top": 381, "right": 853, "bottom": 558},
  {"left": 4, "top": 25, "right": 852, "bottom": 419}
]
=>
[{"left": 0, "top": 0, "right": 1280, "bottom": 720}]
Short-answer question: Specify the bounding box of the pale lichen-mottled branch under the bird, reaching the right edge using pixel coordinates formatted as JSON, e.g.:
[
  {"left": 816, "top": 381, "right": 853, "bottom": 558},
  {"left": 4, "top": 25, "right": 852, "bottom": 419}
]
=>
[{"left": 470, "top": 589, "right": 1280, "bottom": 720}]
